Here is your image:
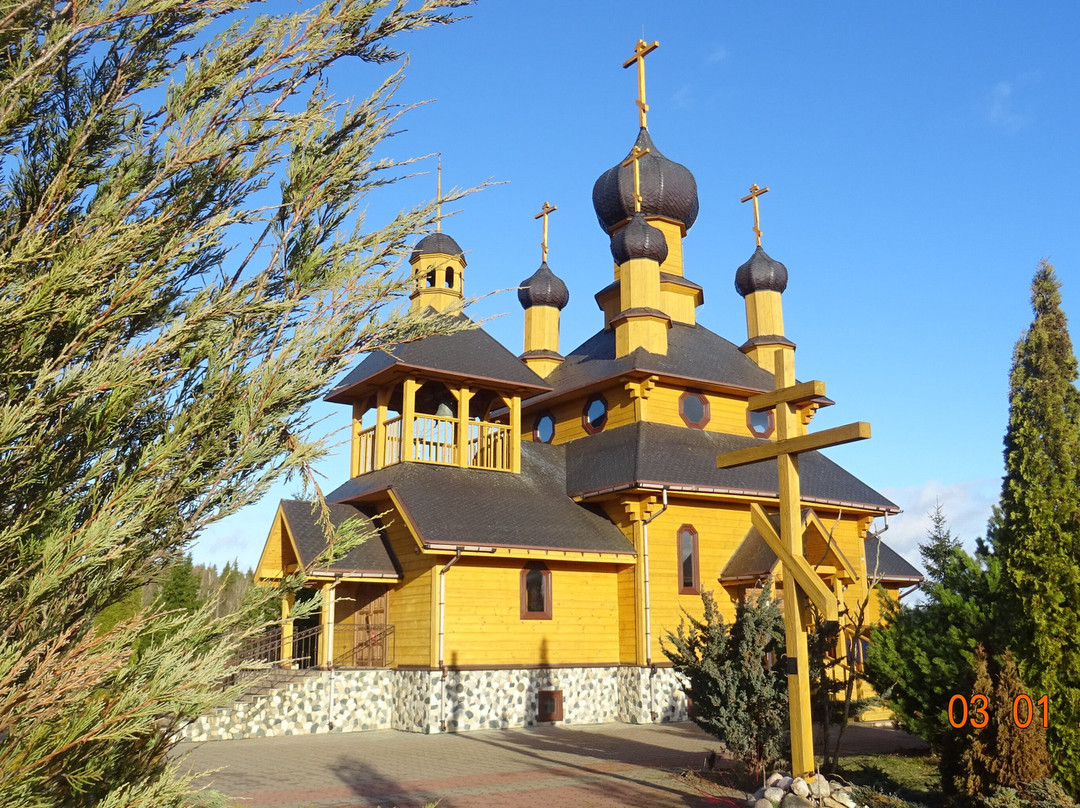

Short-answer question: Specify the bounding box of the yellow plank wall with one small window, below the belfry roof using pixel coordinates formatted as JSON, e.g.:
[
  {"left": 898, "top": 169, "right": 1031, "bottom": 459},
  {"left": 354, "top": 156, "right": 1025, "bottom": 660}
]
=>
[{"left": 438, "top": 556, "right": 619, "bottom": 666}]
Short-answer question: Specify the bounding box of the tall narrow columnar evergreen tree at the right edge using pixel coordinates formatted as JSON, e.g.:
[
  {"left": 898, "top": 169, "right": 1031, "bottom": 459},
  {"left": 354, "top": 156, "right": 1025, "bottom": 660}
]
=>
[{"left": 990, "top": 261, "right": 1080, "bottom": 795}]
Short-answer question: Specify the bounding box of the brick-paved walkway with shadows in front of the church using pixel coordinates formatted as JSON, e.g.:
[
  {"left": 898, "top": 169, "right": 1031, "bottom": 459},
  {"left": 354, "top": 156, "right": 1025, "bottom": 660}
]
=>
[{"left": 178, "top": 724, "right": 919, "bottom": 808}]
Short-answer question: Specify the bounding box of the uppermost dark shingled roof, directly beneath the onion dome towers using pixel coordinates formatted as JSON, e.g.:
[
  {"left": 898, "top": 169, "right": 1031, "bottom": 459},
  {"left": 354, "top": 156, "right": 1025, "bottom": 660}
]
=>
[{"left": 528, "top": 323, "right": 773, "bottom": 406}]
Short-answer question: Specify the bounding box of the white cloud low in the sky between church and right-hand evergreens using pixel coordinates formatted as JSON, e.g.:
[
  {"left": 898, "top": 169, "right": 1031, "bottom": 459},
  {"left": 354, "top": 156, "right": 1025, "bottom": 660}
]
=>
[{"left": 876, "top": 477, "right": 1001, "bottom": 569}]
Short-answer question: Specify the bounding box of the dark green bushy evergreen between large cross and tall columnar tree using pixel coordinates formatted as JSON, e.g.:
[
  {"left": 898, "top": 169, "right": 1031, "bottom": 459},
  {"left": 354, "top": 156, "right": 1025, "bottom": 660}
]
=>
[{"left": 865, "top": 509, "right": 1008, "bottom": 748}]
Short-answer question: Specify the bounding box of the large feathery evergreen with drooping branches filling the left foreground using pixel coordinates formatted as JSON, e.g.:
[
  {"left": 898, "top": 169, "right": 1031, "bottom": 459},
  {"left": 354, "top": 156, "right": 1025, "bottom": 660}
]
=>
[{"left": 0, "top": 0, "right": 470, "bottom": 808}]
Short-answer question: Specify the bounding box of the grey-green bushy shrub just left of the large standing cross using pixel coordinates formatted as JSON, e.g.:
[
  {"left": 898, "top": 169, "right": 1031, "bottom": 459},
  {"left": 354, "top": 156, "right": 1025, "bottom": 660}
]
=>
[{"left": 662, "top": 587, "right": 788, "bottom": 778}]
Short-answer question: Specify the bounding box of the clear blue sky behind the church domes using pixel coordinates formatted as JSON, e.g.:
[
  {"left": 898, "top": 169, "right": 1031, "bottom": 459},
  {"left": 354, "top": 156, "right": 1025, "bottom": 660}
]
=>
[{"left": 193, "top": 0, "right": 1080, "bottom": 566}]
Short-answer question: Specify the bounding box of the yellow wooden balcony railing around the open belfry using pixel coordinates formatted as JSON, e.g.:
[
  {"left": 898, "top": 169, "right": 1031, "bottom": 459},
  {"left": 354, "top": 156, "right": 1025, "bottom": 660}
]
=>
[{"left": 356, "top": 415, "right": 513, "bottom": 474}]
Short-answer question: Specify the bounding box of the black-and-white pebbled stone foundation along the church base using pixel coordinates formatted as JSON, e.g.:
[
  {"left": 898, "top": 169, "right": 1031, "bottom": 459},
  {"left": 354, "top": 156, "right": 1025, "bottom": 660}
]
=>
[{"left": 181, "top": 666, "right": 687, "bottom": 741}]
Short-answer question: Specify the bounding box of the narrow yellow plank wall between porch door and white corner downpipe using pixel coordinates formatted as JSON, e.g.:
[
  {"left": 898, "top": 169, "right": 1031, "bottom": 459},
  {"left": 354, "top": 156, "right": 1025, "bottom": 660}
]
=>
[{"left": 386, "top": 514, "right": 438, "bottom": 666}]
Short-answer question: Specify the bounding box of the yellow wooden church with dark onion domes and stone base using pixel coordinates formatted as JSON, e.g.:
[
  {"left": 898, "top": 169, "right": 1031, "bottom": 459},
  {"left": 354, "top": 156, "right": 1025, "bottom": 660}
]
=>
[{"left": 257, "top": 42, "right": 921, "bottom": 732}]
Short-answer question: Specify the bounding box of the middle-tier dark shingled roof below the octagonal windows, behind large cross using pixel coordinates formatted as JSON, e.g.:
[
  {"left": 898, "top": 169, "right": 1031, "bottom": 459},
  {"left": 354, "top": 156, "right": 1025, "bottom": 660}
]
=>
[{"left": 566, "top": 422, "right": 900, "bottom": 513}]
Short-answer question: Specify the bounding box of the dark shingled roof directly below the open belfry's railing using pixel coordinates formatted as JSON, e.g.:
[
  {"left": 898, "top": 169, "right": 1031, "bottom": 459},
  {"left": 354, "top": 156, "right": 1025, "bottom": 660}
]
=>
[{"left": 327, "top": 442, "right": 634, "bottom": 555}]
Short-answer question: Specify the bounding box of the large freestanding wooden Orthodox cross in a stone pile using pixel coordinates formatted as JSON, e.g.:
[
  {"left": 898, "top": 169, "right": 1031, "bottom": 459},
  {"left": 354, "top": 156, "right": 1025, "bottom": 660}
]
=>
[{"left": 716, "top": 350, "right": 870, "bottom": 776}]
